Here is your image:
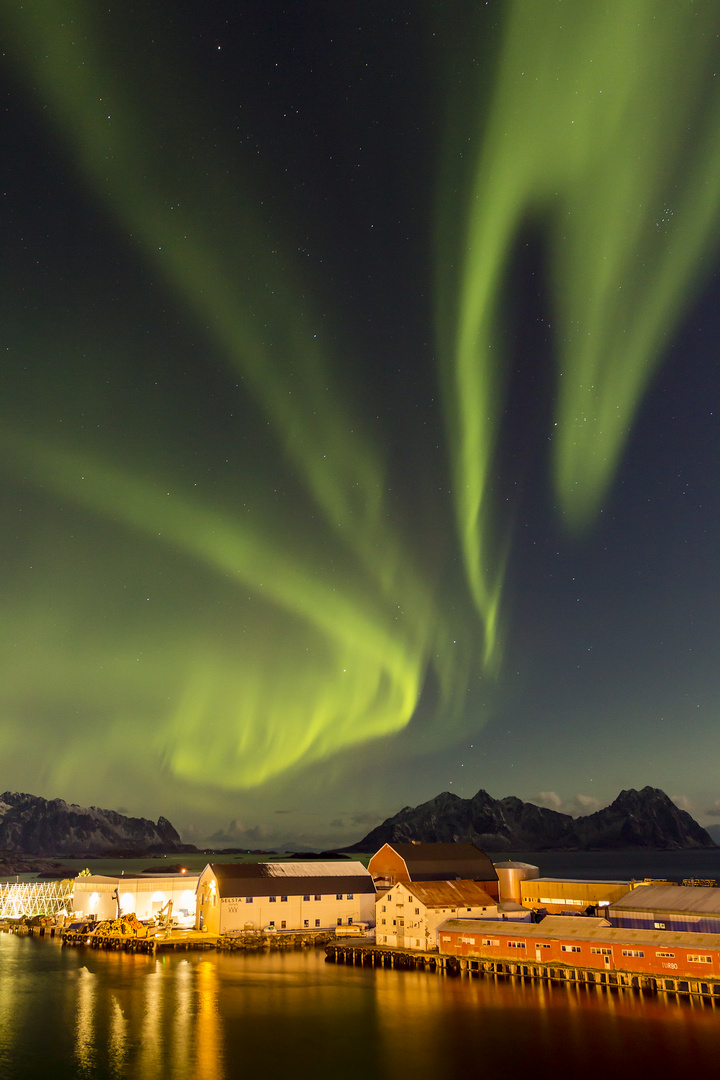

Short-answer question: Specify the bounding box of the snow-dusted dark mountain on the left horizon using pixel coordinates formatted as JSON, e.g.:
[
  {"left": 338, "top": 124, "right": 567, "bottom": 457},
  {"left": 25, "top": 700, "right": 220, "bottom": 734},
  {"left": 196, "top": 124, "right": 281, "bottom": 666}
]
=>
[{"left": 0, "top": 792, "right": 195, "bottom": 858}]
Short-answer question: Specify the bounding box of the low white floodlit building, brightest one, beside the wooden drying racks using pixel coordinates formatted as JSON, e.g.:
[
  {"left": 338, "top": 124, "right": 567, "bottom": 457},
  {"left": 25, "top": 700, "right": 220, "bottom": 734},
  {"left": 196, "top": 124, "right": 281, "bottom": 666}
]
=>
[{"left": 72, "top": 874, "right": 199, "bottom": 919}]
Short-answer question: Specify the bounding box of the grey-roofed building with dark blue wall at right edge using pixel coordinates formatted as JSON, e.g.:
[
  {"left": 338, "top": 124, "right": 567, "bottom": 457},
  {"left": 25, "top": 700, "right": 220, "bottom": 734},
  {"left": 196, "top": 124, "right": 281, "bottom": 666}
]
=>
[{"left": 608, "top": 885, "right": 720, "bottom": 934}]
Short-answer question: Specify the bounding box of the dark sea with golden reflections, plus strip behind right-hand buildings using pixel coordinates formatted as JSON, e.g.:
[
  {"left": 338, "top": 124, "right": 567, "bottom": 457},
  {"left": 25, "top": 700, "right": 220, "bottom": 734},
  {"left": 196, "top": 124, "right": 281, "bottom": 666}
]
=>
[{"left": 0, "top": 851, "right": 720, "bottom": 1080}]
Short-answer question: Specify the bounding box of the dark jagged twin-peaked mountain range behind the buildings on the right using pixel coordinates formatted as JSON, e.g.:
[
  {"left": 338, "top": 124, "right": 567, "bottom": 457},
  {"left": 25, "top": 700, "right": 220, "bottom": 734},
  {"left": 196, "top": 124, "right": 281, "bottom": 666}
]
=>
[{"left": 344, "top": 787, "right": 715, "bottom": 851}]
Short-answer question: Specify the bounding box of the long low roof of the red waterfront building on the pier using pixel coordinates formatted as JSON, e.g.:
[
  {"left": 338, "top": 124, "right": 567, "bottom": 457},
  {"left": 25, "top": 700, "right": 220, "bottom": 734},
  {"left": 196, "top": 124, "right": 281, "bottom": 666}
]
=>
[{"left": 437, "top": 915, "right": 720, "bottom": 949}]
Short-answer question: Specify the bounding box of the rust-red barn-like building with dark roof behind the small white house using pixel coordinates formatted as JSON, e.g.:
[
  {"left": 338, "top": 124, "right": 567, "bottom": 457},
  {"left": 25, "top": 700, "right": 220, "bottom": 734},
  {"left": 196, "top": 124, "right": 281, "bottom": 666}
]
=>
[{"left": 367, "top": 841, "right": 500, "bottom": 900}]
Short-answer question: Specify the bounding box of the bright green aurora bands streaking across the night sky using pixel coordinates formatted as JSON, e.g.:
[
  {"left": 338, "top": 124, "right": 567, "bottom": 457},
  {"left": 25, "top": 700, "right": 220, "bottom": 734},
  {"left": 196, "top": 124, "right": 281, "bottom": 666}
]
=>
[{"left": 0, "top": 0, "right": 720, "bottom": 838}]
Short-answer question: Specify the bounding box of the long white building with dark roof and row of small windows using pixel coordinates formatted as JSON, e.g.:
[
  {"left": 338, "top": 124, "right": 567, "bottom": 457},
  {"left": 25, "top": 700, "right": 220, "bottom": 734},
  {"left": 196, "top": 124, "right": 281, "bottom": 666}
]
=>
[{"left": 195, "top": 862, "right": 376, "bottom": 934}]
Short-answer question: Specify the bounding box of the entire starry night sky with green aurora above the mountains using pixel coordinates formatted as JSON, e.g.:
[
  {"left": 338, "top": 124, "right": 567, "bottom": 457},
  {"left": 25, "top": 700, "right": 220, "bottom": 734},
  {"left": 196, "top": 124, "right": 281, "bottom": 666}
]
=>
[{"left": 0, "top": 0, "right": 720, "bottom": 847}]
